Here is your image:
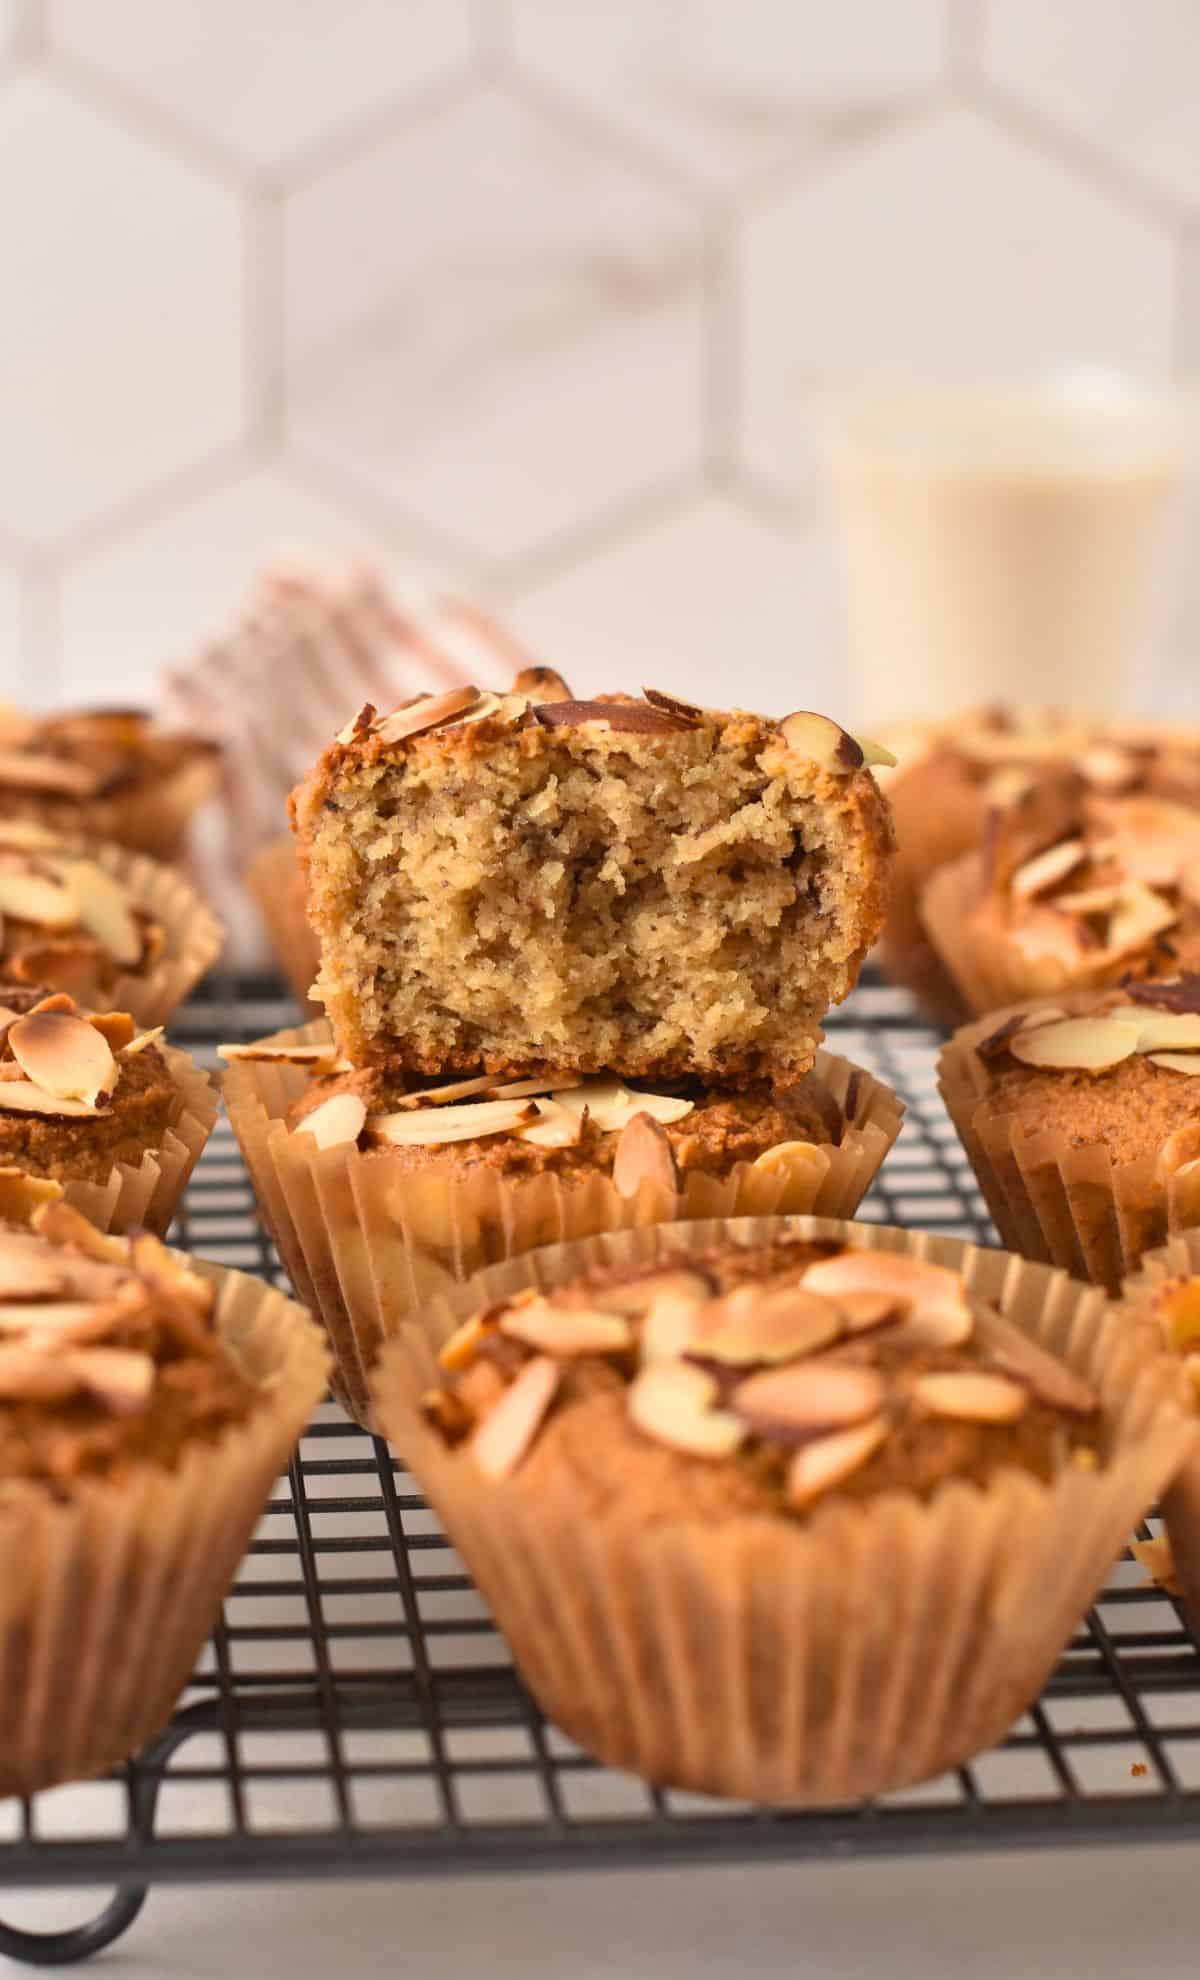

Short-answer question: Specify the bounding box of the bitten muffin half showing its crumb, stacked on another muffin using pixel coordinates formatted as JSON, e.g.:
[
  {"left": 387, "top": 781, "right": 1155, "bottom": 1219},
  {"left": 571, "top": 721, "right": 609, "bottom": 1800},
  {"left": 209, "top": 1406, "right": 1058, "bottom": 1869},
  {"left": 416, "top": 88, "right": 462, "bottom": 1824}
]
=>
[{"left": 291, "top": 687, "right": 889, "bottom": 1085}]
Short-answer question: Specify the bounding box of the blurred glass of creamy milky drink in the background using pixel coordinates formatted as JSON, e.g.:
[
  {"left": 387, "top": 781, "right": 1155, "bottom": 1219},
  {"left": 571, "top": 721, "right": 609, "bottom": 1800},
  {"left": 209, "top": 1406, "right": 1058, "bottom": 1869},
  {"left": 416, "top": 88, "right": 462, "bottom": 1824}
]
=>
[{"left": 834, "top": 390, "right": 1180, "bottom": 721}]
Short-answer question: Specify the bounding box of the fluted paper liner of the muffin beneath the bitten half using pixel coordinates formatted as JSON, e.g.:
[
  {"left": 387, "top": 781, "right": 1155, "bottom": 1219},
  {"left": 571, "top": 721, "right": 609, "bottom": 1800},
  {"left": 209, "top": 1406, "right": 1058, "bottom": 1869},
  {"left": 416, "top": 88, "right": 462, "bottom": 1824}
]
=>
[{"left": 222, "top": 1020, "right": 903, "bottom": 1428}]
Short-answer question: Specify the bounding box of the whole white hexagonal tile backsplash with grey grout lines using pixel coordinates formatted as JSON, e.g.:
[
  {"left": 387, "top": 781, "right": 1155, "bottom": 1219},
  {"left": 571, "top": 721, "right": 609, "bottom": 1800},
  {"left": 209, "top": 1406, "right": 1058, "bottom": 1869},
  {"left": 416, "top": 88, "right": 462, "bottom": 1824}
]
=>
[{"left": 0, "top": 0, "right": 1200, "bottom": 711}]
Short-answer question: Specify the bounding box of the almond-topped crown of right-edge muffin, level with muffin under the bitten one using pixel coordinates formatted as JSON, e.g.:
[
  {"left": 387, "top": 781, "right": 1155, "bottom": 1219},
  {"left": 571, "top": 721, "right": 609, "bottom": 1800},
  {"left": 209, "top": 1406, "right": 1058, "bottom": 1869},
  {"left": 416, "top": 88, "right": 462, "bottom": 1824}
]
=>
[{"left": 960, "top": 974, "right": 1200, "bottom": 1174}]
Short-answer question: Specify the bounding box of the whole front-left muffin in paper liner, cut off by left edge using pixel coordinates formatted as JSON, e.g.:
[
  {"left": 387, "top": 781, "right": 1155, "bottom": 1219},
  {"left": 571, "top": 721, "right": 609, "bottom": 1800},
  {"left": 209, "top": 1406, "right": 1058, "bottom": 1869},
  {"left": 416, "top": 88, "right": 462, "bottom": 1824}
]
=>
[{"left": 0, "top": 1202, "right": 325, "bottom": 1794}]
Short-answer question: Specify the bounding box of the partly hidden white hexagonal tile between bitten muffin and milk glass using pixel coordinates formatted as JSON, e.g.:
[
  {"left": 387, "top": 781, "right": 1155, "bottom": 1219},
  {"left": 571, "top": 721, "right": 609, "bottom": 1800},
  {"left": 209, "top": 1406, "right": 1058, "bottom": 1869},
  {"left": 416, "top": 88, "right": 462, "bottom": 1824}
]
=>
[{"left": 500, "top": 495, "right": 850, "bottom": 717}]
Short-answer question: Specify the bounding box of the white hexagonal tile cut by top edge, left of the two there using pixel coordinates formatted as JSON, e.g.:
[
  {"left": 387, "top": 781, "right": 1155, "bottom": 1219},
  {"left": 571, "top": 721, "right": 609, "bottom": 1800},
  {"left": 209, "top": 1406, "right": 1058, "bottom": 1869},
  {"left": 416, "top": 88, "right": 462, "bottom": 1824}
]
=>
[{"left": 50, "top": 0, "right": 473, "bottom": 166}]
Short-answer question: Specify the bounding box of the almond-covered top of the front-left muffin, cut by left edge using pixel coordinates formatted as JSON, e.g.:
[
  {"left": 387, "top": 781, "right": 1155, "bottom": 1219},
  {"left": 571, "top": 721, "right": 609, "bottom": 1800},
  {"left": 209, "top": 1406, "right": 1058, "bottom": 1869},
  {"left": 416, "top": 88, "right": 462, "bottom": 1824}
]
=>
[{"left": 0, "top": 1204, "right": 257, "bottom": 1499}]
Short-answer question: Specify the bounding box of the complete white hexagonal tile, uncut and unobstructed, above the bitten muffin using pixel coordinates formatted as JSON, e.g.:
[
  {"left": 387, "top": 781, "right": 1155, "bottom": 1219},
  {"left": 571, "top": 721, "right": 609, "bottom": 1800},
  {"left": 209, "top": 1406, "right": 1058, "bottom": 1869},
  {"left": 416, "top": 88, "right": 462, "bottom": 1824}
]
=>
[{"left": 285, "top": 91, "right": 703, "bottom": 558}]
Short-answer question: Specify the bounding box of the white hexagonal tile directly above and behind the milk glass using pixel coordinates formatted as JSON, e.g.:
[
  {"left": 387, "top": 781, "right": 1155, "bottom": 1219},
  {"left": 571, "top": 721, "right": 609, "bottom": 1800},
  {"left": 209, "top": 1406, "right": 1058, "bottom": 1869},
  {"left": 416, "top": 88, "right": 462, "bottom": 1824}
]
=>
[{"left": 737, "top": 109, "right": 1174, "bottom": 502}]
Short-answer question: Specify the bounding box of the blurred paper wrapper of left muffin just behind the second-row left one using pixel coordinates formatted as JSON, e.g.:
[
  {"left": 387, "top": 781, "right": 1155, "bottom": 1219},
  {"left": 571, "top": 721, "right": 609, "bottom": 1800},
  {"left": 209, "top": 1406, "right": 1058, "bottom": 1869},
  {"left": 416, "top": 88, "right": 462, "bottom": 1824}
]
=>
[{"left": 32, "top": 845, "right": 224, "bottom": 1030}]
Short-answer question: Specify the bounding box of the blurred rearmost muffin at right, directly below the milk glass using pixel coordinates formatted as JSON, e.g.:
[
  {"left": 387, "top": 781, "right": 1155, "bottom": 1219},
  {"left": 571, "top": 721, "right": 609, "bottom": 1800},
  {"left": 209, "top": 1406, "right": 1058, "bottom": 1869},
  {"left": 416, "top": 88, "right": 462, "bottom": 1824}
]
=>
[{"left": 879, "top": 707, "right": 1200, "bottom": 1024}]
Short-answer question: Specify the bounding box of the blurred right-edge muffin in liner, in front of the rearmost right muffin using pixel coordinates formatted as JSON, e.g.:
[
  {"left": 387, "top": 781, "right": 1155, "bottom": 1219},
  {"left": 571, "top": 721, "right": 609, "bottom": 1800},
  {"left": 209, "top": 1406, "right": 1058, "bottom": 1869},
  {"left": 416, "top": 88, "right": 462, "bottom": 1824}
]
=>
[{"left": 921, "top": 784, "right": 1200, "bottom": 1014}]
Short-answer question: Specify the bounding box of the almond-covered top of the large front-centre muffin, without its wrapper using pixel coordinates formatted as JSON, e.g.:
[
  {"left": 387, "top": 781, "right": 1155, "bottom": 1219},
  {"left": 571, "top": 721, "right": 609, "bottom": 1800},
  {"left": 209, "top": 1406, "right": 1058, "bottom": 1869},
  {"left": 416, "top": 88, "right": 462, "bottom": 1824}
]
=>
[{"left": 424, "top": 1241, "right": 1099, "bottom": 1525}]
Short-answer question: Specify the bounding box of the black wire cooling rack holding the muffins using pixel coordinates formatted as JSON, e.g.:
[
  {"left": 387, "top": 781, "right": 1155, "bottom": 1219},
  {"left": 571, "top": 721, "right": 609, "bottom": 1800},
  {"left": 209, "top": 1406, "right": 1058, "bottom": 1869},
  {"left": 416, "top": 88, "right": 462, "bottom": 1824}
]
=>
[{"left": 0, "top": 980, "right": 1200, "bottom": 1964}]
